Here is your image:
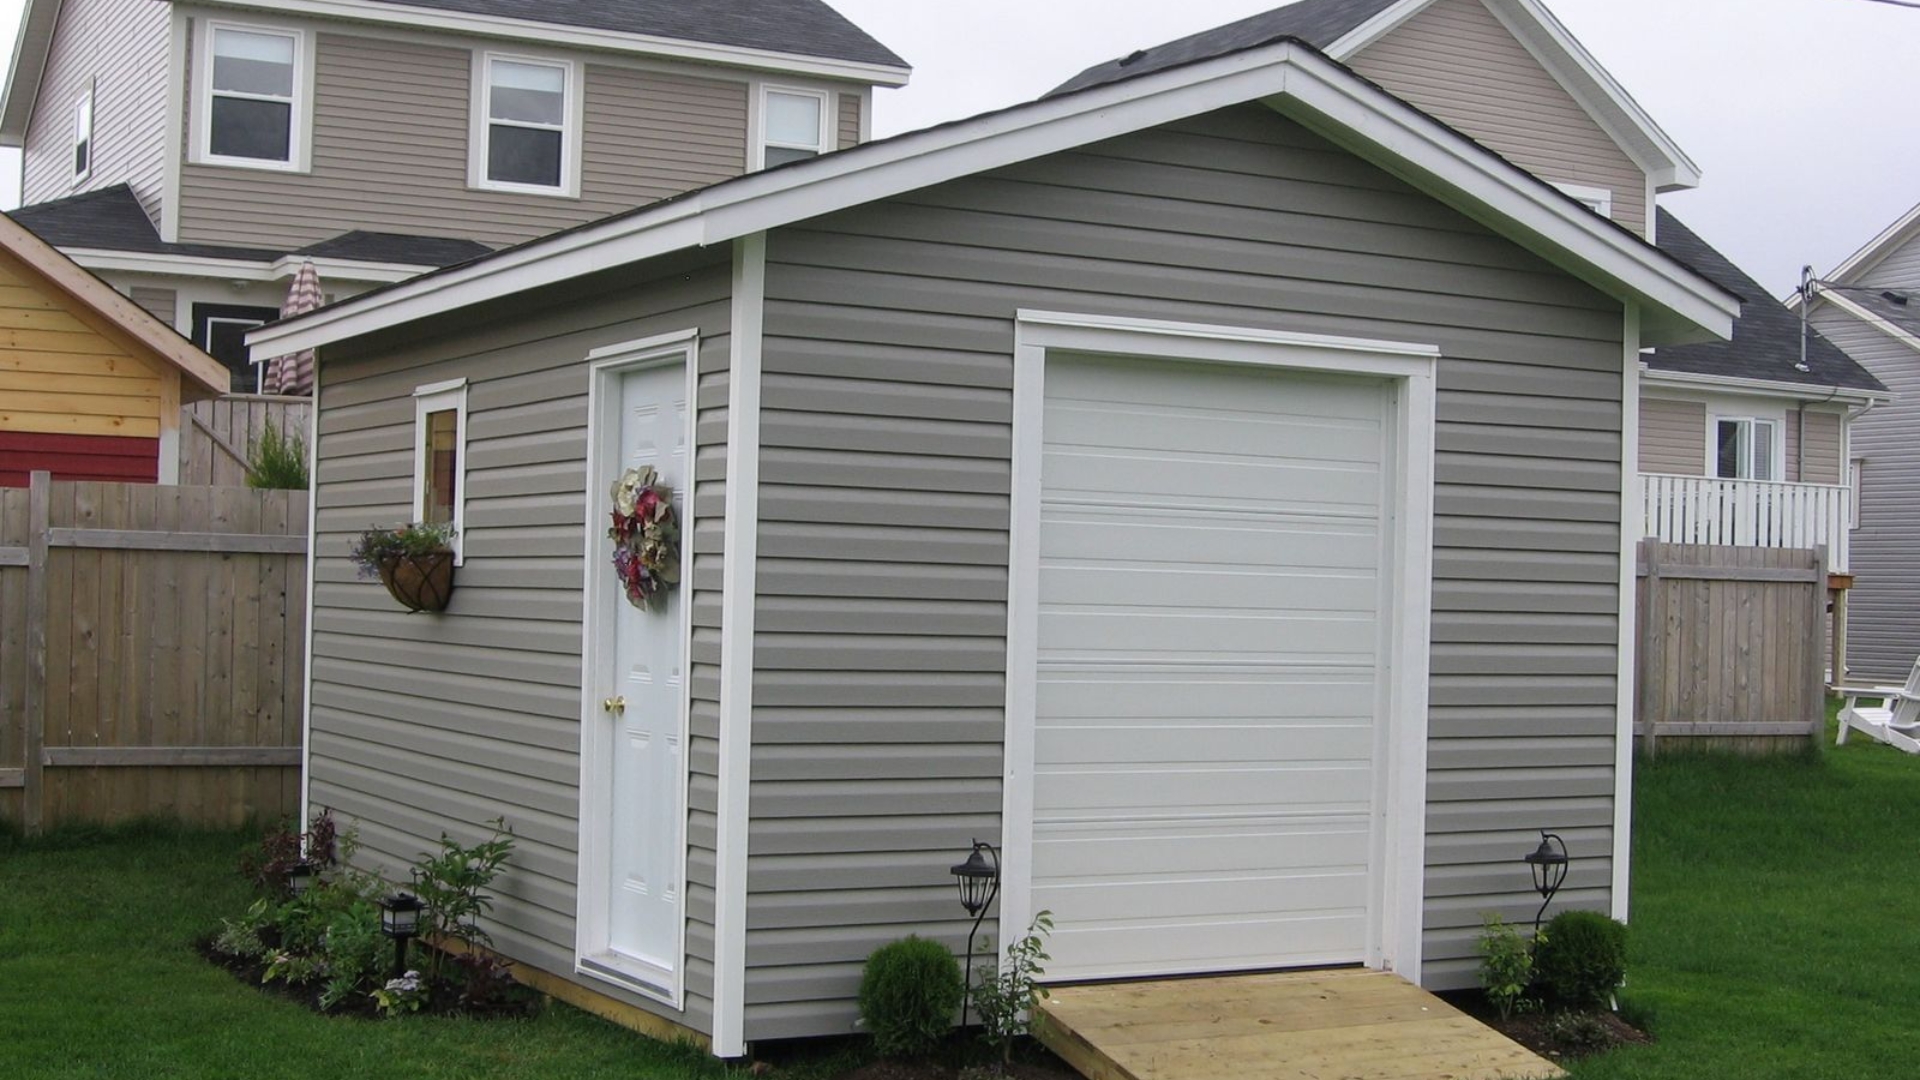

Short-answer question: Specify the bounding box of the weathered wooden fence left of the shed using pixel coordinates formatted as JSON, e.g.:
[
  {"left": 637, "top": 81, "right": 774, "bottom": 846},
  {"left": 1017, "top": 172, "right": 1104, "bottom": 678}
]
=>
[{"left": 0, "top": 473, "right": 307, "bottom": 830}]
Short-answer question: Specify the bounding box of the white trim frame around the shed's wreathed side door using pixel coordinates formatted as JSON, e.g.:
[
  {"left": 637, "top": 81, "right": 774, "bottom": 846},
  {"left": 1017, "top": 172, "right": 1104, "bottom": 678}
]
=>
[{"left": 574, "top": 331, "right": 699, "bottom": 1009}]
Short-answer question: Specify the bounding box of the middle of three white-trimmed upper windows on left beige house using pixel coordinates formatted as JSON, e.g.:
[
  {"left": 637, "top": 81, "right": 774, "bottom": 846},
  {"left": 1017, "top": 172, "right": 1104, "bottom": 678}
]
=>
[{"left": 472, "top": 52, "right": 580, "bottom": 194}]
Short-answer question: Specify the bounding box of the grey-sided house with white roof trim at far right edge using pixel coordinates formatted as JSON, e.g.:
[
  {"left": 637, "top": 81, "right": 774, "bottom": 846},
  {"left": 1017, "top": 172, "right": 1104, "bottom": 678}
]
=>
[{"left": 1809, "top": 206, "right": 1920, "bottom": 682}]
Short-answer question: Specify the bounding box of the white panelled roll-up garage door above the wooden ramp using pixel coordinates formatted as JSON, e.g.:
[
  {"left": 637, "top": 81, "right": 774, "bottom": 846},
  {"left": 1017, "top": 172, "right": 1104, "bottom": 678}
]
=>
[{"left": 1033, "top": 354, "right": 1392, "bottom": 978}]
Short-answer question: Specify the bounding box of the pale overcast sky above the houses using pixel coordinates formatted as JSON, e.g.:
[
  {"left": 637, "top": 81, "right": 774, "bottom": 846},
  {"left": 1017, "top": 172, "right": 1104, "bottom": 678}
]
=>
[{"left": 0, "top": 0, "right": 1920, "bottom": 294}]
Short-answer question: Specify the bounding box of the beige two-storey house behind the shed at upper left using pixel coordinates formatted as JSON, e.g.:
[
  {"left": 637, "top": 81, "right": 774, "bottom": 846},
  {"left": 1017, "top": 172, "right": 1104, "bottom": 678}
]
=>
[{"left": 0, "top": 0, "right": 908, "bottom": 390}]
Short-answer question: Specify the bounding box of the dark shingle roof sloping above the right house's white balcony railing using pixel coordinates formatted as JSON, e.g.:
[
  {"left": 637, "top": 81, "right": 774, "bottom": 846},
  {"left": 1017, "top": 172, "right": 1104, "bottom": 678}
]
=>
[{"left": 1647, "top": 208, "right": 1885, "bottom": 390}]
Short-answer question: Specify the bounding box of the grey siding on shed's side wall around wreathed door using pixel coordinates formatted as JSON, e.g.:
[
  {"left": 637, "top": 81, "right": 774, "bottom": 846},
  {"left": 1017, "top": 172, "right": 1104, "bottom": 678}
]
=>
[{"left": 311, "top": 256, "right": 732, "bottom": 1032}]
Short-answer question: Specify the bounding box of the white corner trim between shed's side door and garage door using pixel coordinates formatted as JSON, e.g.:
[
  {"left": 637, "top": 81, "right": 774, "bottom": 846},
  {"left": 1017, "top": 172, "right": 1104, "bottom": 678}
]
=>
[{"left": 712, "top": 233, "right": 766, "bottom": 1057}]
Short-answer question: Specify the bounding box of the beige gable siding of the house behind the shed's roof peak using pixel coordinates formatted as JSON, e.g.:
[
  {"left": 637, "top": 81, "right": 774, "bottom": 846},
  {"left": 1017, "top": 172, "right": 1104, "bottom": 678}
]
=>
[{"left": 1350, "top": 0, "right": 1647, "bottom": 234}]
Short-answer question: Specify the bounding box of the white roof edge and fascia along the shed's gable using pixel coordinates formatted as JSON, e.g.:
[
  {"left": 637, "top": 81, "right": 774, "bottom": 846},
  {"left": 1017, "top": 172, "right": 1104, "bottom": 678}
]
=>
[{"left": 248, "top": 40, "right": 1740, "bottom": 356}]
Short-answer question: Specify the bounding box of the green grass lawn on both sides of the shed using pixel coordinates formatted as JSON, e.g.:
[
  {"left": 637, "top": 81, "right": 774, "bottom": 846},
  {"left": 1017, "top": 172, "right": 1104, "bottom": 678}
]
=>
[{"left": 11, "top": 711, "right": 1920, "bottom": 1080}]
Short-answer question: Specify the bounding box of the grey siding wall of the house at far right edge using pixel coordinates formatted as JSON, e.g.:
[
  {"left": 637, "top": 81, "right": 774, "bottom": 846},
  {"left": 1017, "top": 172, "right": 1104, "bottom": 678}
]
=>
[{"left": 1812, "top": 303, "right": 1920, "bottom": 682}]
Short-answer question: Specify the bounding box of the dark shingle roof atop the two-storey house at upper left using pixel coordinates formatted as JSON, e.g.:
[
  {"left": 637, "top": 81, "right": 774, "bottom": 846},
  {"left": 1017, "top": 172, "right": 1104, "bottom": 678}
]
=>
[{"left": 364, "top": 0, "right": 906, "bottom": 67}]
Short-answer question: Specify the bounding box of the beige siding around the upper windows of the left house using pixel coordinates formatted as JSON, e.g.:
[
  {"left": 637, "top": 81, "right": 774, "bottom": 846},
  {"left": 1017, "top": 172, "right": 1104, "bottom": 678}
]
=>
[{"left": 180, "top": 33, "right": 747, "bottom": 248}]
